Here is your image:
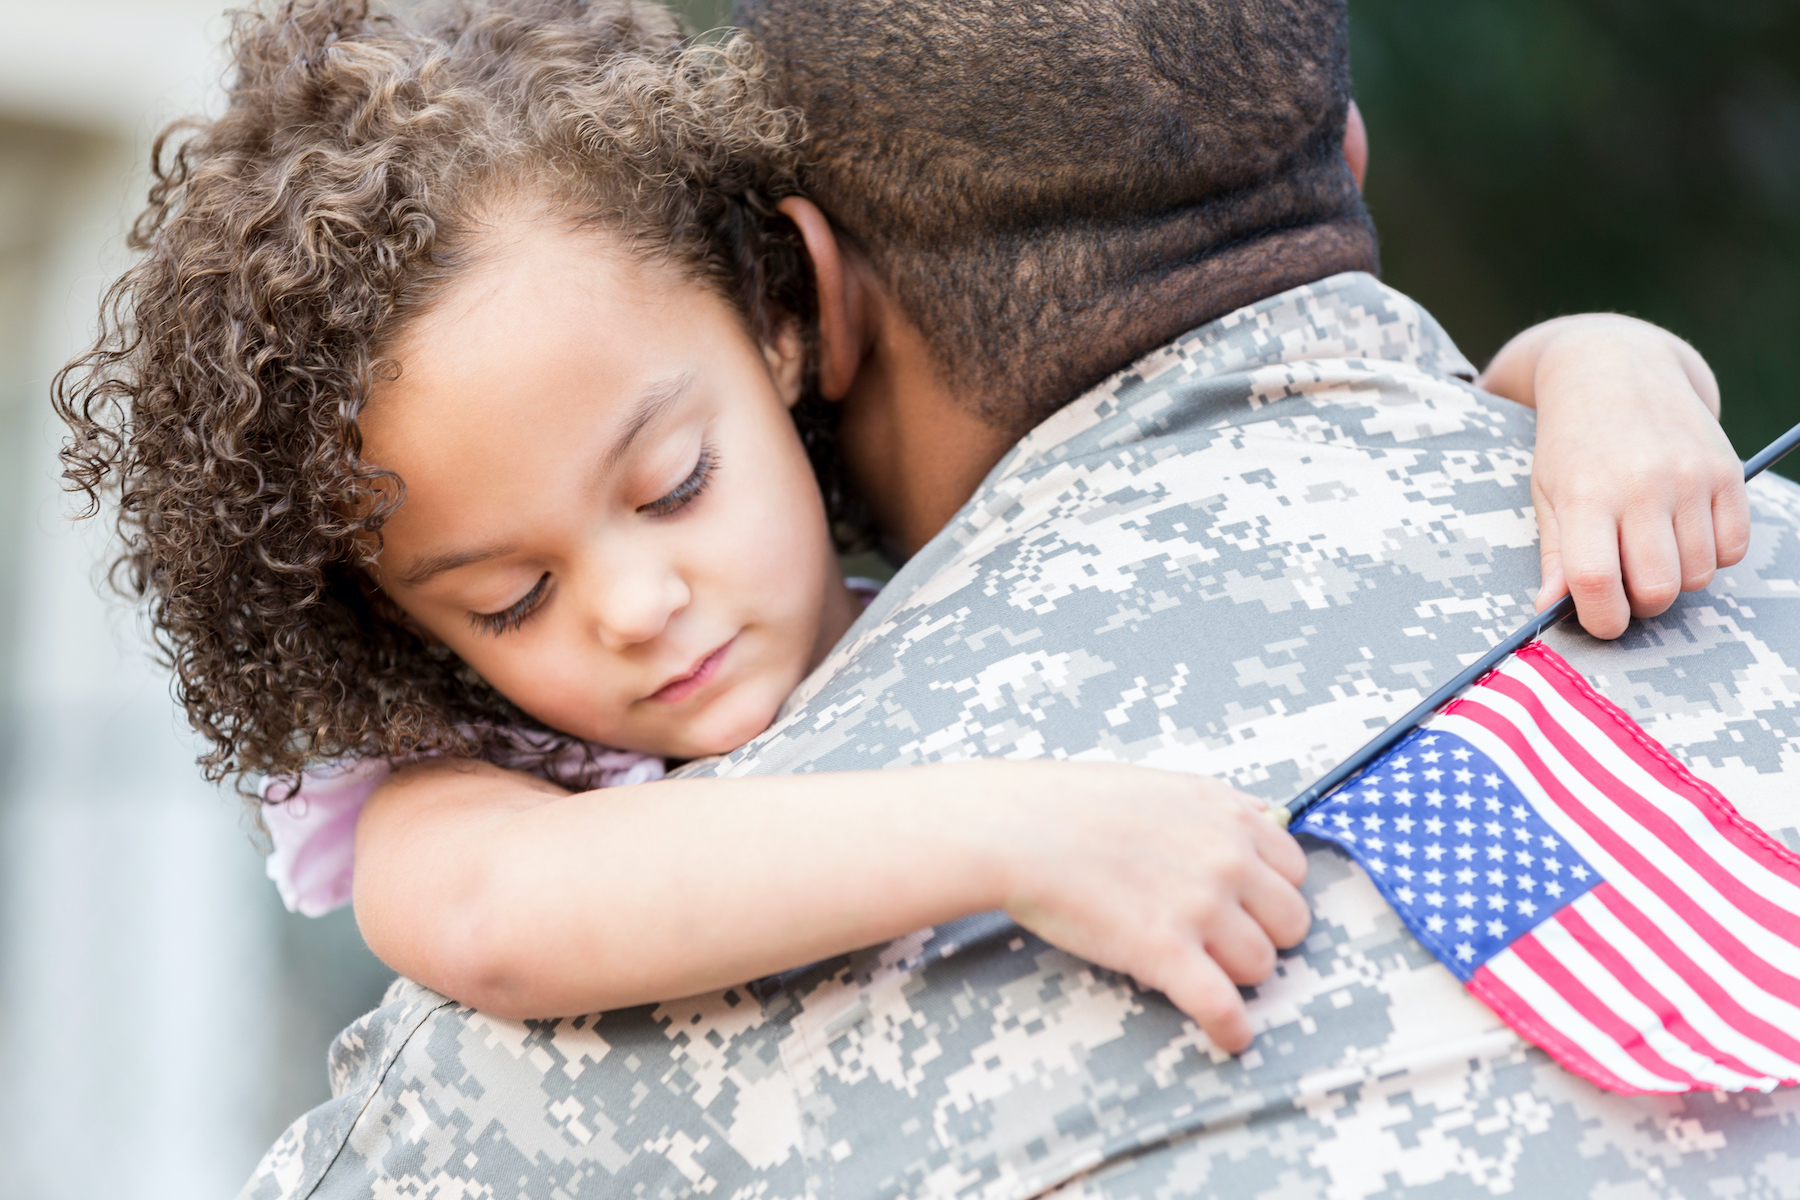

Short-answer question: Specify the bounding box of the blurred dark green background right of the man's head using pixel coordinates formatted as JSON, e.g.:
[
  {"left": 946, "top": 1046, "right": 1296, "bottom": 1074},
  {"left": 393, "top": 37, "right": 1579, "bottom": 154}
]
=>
[{"left": 682, "top": 0, "right": 1800, "bottom": 479}]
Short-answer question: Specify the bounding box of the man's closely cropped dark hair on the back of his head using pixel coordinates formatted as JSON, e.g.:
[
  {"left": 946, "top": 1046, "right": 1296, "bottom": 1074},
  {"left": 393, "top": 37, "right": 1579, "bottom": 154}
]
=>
[{"left": 736, "top": 0, "right": 1375, "bottom": 432}]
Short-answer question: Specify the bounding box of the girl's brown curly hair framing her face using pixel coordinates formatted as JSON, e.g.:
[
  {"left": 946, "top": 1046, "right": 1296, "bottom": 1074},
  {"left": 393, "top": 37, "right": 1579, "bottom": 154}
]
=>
[{"left": 54, "top": 0, "right": 844, "bottom": 791}]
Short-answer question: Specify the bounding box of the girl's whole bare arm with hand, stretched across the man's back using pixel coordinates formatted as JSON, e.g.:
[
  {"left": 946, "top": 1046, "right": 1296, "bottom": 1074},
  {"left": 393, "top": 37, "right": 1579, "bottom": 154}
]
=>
[{"left": 355, "top": 759, "right": 1310, "bottom": 1049}]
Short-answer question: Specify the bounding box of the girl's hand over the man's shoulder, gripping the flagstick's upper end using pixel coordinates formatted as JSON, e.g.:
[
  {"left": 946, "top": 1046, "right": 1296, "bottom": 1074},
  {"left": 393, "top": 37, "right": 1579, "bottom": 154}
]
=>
[{"left": 1478, "top": 315, "right": 1750, "bottom": 637}]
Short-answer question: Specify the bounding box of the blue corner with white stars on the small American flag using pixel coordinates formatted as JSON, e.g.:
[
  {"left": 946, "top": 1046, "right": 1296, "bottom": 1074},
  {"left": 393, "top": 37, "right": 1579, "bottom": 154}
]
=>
[{"left": 1292, "top": 729, "right": 1600, "bottom": 982}]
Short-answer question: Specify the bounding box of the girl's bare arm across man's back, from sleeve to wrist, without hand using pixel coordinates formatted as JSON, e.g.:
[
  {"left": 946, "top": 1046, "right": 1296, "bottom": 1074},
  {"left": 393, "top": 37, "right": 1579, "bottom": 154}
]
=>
[{"left": 356, "top": 763, "right": 1021, "bottom": 1016}]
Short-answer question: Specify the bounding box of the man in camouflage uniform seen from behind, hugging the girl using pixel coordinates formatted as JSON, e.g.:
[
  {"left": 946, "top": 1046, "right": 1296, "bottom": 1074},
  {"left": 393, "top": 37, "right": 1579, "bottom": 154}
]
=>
[{"left": 245, "top": 0, "right": 1800, "bottom": 1200}]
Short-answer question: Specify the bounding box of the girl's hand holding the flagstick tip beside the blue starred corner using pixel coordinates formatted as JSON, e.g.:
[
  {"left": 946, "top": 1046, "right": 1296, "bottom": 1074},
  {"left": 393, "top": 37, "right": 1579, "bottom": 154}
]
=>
[{"left": 995, "top": 763, "right": 1312, "bottom": 1052}]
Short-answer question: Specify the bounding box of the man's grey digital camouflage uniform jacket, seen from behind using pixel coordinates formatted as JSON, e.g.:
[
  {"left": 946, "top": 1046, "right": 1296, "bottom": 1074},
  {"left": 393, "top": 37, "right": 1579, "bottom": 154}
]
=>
[{"left": 243, "top": 273, "right": 1800, "bottom": 1200}]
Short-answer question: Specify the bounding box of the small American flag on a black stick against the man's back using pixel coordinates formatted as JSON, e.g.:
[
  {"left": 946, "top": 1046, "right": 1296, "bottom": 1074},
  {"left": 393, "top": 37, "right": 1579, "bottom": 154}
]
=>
[{"left": 1292, "top": 642, "right": 1800, "bottom": 1094}]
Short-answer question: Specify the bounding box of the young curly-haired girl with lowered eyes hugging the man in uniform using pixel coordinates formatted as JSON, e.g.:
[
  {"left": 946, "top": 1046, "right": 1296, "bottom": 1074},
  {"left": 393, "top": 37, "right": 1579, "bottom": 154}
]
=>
[{"left": 59, "top": 0, "right": 1741, "bottom": 1049}]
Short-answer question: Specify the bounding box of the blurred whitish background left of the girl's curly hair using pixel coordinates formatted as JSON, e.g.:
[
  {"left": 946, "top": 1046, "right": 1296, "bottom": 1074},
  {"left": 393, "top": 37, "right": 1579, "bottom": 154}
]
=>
[{"left": 0, "top": 0, "right": 394, "bottom": 1200}]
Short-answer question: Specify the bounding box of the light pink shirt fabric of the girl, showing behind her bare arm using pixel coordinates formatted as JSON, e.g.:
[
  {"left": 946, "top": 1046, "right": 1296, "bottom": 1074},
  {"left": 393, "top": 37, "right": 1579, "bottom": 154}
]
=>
[{"left": 263, "top": 750, "right": 662, "bottom": 918}]
